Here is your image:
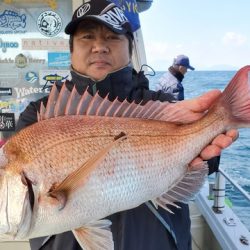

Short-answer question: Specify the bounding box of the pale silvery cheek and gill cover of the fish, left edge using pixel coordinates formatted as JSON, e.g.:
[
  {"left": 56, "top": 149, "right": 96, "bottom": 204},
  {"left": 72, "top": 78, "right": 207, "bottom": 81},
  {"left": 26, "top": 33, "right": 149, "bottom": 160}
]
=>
[{"left": 0, "top": 148, "right": 32, "bottom": 240}]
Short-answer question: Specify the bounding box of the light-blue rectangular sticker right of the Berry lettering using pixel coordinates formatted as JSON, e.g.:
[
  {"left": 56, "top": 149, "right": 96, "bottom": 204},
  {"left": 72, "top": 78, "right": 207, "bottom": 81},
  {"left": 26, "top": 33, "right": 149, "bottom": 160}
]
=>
[{"left": 48, "top": 52, "right": 70, "bottom": 68}]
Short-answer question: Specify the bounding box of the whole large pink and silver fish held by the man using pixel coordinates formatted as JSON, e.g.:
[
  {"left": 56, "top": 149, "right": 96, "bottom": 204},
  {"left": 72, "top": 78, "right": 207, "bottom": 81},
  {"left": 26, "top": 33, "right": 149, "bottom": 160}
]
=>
[{"left": 0, "top": 66, "right": 250, "bottom": 249}]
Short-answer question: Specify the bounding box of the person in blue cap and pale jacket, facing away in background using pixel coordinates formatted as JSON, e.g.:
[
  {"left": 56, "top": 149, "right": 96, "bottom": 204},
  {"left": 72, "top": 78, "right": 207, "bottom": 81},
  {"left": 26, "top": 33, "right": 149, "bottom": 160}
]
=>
[{"left": 156, "top": 55, "right": 194, "bottom": 101}]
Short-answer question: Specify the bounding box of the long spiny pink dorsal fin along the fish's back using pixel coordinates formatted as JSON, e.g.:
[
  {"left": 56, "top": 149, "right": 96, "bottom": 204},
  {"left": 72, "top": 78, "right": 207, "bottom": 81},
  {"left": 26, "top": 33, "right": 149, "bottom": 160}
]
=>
[{"left": 38, "top": 83, "right": 183, "bottom": 121}]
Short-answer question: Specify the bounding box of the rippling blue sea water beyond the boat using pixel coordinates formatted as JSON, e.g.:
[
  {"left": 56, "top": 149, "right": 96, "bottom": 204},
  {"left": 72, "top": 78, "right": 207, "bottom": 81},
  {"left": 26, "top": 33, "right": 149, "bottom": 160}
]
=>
[{"left": 147, "top": 71, "right": 250, "bottom": 230}]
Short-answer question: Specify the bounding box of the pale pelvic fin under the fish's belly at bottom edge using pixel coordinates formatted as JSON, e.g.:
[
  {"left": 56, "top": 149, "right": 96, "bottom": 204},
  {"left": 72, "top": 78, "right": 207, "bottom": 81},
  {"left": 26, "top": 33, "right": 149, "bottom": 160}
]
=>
[{"left": 72, "top": 220, "right": 114, "bottom": 250}]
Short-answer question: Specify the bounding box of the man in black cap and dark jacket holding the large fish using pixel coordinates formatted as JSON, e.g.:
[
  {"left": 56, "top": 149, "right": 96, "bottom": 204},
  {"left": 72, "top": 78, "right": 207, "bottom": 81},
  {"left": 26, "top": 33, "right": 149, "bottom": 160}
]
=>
[{"left": 17, "top": 0, "right": 238, "bottom": 250}]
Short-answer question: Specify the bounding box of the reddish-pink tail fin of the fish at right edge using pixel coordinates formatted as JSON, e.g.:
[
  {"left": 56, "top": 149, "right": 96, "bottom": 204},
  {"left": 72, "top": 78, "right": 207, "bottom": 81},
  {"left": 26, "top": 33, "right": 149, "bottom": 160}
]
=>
[{"left": 219, "top": 65, "right": 250, "bottom": 128}]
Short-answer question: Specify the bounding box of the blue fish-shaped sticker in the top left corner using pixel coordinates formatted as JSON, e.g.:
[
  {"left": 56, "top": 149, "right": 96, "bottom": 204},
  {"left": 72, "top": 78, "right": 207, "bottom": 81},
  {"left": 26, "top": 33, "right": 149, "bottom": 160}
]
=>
[{"left": 0, "top": 10, "right": 26, "bottom": 30}]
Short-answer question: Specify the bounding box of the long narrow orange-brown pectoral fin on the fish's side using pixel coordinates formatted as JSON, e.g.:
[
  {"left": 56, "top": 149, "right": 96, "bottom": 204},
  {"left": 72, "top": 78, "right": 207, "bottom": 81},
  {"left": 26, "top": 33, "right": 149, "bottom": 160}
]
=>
[{"left": 48, "top": 132, "right": 127, "bottom": 210}]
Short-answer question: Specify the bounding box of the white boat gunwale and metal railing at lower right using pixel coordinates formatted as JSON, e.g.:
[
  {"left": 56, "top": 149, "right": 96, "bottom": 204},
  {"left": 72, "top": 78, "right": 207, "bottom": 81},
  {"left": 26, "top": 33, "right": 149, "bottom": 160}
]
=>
[{"left": 195, "top": 169, "right": 250, "bottom": 250}]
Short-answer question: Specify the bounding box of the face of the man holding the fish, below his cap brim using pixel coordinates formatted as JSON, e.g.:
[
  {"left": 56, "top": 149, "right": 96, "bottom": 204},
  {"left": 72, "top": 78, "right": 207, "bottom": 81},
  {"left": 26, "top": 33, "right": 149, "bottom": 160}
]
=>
[{"left": 71, "top": 21, "right": 130, "bottom": 80}]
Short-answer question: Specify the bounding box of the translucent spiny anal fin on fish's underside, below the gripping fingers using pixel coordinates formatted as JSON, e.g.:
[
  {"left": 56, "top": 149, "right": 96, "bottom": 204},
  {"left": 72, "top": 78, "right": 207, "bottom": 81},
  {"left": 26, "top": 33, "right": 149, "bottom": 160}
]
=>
[{"left": 155, "top": 162, "right": 208, "bottom": 212}]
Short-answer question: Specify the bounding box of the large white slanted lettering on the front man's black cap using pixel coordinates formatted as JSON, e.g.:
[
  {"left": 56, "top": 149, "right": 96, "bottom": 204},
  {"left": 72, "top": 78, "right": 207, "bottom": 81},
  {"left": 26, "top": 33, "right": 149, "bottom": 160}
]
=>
[{"left": 100, "top": 7, "right": 128, "bottom": 30}]
